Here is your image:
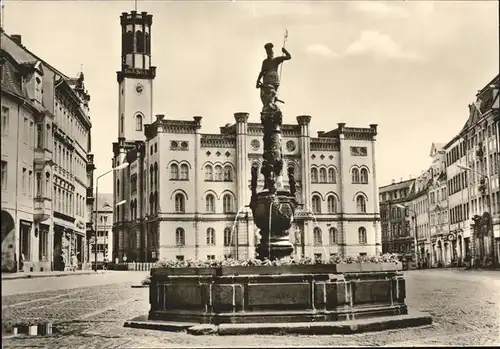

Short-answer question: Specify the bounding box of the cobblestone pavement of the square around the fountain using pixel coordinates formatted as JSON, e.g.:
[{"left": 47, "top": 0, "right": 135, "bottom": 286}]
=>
[{"left": 2, "top": 269, "right": 500, "bottom": 348}]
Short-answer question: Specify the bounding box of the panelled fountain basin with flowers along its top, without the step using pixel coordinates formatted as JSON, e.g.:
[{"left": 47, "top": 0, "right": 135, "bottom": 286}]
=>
[{"left": 145, "top": 255, "right": 407, "bottom": 324}]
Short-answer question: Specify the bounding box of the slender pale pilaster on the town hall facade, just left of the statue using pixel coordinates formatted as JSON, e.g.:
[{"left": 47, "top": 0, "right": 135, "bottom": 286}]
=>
[{"left": 234, "top": 113, "right": 250, "bottom": 259}]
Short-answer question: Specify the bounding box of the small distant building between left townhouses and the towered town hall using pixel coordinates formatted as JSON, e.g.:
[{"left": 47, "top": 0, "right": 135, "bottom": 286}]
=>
[{"left": 90, "top": 194, "right": 113, "bottom": 265}]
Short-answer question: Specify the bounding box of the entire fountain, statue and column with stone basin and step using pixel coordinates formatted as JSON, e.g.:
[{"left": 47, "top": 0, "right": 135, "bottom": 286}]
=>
[{"left": 125, "top": 40, "right": 431, "bottom": 335}]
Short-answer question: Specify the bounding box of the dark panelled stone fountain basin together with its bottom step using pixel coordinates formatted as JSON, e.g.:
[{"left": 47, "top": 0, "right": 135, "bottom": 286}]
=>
[{"left": 125, "top": 262, "right": 432, "bottom": 335}]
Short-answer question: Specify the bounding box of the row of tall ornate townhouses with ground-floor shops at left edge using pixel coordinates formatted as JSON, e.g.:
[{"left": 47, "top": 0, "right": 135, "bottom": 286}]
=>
[{"left": 1, "top": 31, "right": 93, "bottom": 272}]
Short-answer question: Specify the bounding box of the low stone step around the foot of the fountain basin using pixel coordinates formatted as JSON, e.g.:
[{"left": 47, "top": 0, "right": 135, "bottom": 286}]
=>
[{"left": 123, "top": 309, "right": 432, "bottom": 336}]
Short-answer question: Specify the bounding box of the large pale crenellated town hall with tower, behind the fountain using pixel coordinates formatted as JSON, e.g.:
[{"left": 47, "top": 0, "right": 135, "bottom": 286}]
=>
[{"left": 113, "top": 11, "right": 381, "bottom": 262}]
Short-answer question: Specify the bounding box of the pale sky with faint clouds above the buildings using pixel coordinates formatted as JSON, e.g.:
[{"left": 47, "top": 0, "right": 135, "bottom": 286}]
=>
[{"left": 4, "top": 0, "right": 499, "bottom": 192}]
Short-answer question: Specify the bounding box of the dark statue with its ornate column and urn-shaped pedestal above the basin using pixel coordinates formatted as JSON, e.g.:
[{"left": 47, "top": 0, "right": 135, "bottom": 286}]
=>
[{"left": 250, "top": 40, "right": 297, "bottom": 259}]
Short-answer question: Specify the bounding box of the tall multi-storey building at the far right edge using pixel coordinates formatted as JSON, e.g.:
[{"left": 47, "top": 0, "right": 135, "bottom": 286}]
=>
[{"left": 445, "top": 75, "right": 500, "bottom": 265}]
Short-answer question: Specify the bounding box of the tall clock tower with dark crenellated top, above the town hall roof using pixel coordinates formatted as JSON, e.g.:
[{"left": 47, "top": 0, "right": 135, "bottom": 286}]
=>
[{"left": 117, "top": 11, "right": 156, "bottom": 142}]
